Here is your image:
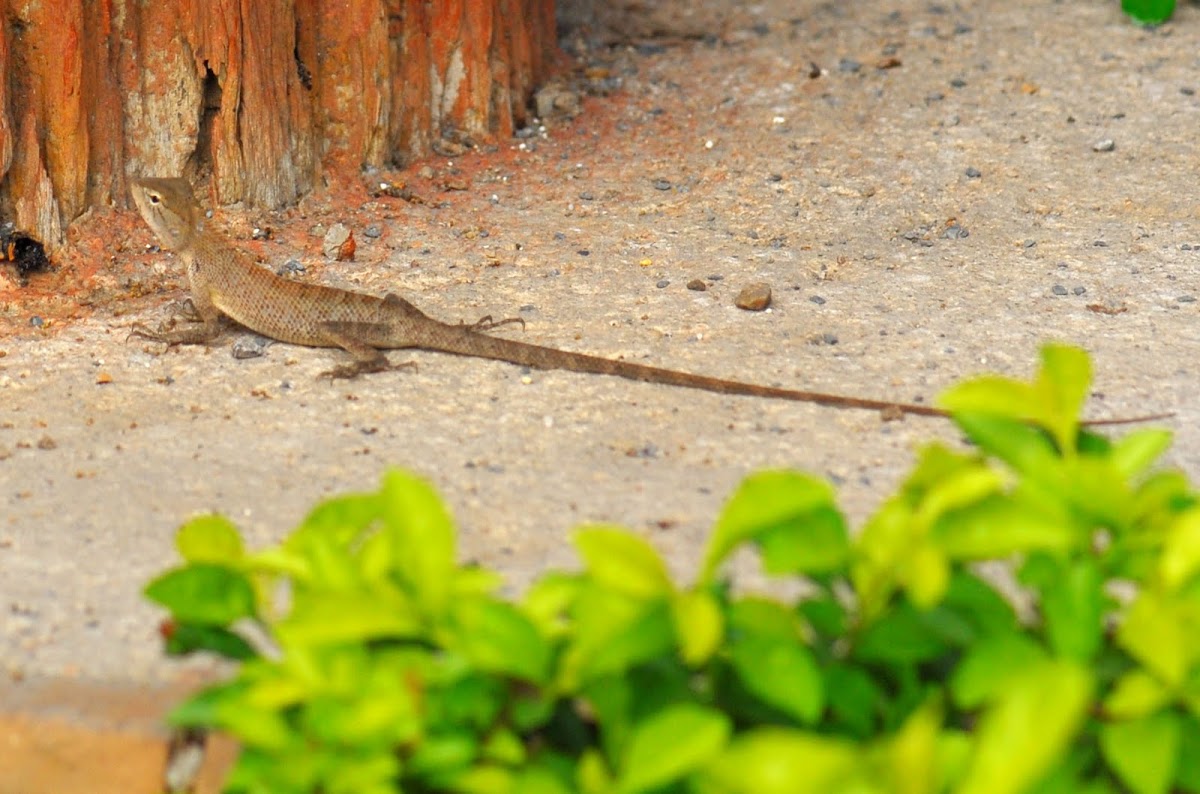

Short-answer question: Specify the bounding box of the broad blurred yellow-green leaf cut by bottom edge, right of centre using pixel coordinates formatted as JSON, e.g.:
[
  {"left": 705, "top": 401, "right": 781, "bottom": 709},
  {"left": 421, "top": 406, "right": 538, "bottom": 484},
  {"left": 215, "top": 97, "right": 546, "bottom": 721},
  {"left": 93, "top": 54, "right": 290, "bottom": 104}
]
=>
[{"left": 707, "top": 728, "right": 874, "bottom": 794}]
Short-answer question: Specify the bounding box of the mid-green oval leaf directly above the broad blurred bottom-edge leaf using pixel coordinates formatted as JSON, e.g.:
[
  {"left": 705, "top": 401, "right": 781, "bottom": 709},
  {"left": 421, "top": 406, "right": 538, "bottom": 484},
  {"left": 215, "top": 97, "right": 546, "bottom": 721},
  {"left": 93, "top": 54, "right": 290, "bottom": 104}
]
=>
[{"left": 731, "top": 634, "right": 824, "bottom": 724}]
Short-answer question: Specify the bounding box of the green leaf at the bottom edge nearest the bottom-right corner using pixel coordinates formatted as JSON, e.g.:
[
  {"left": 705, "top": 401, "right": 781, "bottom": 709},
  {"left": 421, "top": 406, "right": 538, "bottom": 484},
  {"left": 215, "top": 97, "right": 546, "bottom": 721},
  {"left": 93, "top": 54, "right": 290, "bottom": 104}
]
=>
[{"left": 1100, "top": 712, "right": 1181, "bottom": 794}]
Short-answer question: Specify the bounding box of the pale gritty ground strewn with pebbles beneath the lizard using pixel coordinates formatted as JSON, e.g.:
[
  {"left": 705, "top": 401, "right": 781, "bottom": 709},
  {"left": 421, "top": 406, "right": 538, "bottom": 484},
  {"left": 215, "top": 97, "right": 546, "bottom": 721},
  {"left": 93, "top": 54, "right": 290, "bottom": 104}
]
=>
[{"left": 0, "top": 0, "right": 1200, "bottom": 681}]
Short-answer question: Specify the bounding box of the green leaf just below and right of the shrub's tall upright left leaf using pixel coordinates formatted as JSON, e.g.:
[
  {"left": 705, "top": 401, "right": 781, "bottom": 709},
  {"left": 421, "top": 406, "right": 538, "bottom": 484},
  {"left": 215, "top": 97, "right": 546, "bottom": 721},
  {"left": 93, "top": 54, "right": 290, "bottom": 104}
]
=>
[{"left": 452, "top": 596, "right": 551, "bottom": 684}]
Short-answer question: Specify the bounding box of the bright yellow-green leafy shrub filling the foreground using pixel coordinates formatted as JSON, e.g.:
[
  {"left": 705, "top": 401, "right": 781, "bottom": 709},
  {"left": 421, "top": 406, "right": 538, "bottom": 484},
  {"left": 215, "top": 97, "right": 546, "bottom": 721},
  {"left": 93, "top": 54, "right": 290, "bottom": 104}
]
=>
[{"left": 146, "top": 347, "right": 1200, "bottom": 794}]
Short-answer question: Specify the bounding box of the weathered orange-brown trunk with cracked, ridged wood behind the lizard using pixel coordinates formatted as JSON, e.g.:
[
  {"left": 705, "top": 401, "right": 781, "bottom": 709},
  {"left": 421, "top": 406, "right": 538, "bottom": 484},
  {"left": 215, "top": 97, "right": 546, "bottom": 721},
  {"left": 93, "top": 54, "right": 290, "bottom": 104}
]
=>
[{"left": 0, "top": 0, "right": 558, "bottom": 247}]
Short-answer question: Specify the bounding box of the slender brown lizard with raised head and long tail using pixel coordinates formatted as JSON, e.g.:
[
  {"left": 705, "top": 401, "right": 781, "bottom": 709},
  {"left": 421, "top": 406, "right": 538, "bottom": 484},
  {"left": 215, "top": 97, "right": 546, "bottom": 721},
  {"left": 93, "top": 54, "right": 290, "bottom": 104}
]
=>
[{"left": 132, "top": 179, "right": 1156, "bottom": 421}]
